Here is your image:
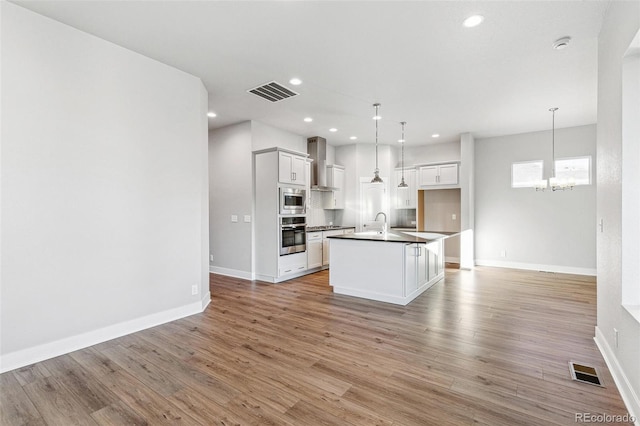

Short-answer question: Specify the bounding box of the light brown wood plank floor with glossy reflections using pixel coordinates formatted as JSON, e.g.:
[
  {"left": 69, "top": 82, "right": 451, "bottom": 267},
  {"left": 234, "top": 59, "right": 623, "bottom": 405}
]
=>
[{"left": 0, "top": 267, "right": 627, "bottom": 426}]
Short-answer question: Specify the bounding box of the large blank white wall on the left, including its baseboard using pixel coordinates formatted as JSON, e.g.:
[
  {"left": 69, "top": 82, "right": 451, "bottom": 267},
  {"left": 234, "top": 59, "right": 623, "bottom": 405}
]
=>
[{"left": 0, "top": 2, "right": 209, "bottom": 370}]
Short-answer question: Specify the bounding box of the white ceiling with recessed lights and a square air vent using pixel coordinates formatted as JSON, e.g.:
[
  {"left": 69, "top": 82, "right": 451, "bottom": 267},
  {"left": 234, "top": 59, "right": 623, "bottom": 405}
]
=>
[{"left": 15, "top": 0, "right": 609, "bottom": 145}]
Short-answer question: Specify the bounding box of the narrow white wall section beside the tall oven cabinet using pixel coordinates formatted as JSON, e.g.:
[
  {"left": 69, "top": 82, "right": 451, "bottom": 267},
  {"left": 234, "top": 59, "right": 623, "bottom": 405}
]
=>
[{"left": 209, "top": 121, "right": 253, "bottom": 278}]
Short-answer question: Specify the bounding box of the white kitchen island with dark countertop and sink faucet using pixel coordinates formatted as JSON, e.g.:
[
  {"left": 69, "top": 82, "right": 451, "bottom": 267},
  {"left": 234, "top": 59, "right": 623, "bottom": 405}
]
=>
[{"left": 329, "top": 230, "right": 457, "bottom": 305}]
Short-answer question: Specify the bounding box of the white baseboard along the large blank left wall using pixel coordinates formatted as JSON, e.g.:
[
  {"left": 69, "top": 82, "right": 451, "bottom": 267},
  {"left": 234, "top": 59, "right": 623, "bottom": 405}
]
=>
[{"left": 0, "top": 300, "right": 211, "bottom": 373}]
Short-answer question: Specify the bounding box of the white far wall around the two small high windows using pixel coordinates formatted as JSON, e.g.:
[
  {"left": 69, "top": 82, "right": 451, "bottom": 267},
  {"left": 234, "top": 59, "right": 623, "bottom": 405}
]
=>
[{"left": 475, "top": 125, "right": 596, "bottom": 275}]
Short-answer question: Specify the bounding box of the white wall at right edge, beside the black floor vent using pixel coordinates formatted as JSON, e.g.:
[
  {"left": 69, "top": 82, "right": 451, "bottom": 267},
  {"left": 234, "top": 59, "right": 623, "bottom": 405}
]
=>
[{"left": 596, "top": 2, "right": 640, "bottom": 417}]
